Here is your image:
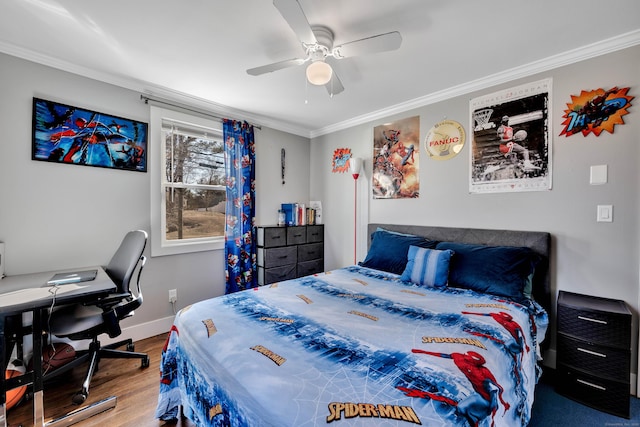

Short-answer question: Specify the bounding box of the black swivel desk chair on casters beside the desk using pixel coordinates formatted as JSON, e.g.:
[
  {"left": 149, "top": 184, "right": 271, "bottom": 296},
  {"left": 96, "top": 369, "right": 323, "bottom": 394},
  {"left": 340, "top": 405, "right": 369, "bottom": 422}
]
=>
[{"left": 43, "top": 230, "right": 149, "bottom": 405}]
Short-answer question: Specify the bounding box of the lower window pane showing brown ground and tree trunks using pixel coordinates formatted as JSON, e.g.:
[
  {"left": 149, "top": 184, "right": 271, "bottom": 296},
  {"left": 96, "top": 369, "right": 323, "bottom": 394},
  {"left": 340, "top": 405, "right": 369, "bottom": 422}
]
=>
[{"left": 165, "top": 188, "right": 226, "bottom": 241}]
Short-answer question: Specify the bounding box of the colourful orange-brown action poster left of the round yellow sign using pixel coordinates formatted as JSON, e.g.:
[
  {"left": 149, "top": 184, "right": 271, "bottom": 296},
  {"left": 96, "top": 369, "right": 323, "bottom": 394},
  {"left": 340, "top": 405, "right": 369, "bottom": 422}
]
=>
[{"left": 372, "top": 116, "right": 420, "bottom": 199}]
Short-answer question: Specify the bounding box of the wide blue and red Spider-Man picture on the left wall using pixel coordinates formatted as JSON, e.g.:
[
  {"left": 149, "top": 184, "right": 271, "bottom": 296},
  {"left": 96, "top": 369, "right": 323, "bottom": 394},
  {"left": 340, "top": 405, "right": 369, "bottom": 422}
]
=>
[{"left": 32, "top": 98, "right": 147, "bottom": 172}]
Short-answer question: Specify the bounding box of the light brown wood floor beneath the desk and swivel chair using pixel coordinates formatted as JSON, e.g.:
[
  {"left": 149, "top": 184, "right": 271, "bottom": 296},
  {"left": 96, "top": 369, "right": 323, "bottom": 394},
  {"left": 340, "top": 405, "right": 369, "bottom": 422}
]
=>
[{"left": 7, "top": 334, "right": 195, "bottom": 427}]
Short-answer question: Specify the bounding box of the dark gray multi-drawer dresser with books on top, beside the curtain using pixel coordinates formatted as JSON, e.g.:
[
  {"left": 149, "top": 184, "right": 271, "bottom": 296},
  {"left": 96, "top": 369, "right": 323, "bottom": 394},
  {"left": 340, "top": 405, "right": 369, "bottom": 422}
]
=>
[{"left": 256, "top": 225, "right": 324, "bottom": 286}]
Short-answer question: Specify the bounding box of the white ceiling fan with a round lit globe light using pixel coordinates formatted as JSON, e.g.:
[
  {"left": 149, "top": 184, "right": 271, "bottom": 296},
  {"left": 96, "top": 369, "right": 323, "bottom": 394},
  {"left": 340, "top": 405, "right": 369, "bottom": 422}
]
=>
[{"left": 247, "top": 0, "right": 402, "bottom": 96}]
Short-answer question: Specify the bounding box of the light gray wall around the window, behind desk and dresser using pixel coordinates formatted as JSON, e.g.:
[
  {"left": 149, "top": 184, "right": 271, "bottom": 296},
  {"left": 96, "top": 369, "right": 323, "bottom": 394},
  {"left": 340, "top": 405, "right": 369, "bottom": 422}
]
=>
[{"left": 0, "top": 54, "right": 310, "bottom": 339}]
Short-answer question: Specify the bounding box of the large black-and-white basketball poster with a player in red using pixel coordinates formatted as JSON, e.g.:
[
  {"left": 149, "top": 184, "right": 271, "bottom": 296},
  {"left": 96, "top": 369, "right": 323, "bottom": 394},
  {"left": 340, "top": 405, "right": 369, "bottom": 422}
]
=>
[{"left": 469, "top": 79, "right": 552, "bottom": 193}]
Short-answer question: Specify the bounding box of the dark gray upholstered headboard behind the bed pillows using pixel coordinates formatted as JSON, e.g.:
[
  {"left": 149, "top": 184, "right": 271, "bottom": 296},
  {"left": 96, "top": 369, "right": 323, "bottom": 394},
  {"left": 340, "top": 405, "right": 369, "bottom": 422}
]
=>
[{"left": 368, "top": 224, "right": 551, "bottom": 313}]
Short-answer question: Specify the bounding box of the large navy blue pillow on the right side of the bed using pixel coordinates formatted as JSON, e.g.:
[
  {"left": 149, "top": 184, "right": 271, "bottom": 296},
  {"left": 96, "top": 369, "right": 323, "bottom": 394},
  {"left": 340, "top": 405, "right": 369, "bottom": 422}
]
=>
[{"left": 436, "top": 242, "right": 540, "bottom": 301}]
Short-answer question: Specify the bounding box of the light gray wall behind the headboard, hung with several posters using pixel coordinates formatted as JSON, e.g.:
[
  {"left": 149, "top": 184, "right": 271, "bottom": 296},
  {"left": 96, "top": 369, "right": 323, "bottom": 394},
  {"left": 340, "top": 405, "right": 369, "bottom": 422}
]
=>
[{"left": 311, "top": 46, "right": 640, "bottom": 380}]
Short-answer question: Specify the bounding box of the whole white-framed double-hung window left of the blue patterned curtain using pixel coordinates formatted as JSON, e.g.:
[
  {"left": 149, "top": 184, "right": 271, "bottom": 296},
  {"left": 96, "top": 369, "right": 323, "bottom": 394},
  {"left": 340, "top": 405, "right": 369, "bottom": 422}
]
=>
[{"left": 149, "top": 106, "right": 226, "bottom": 256}]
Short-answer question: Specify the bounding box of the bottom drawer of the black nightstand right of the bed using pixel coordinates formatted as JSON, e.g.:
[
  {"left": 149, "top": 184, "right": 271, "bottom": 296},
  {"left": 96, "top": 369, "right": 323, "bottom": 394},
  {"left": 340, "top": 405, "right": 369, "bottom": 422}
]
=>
[{"left": 556, "top": 364, "right": 630, "bottom": 418}]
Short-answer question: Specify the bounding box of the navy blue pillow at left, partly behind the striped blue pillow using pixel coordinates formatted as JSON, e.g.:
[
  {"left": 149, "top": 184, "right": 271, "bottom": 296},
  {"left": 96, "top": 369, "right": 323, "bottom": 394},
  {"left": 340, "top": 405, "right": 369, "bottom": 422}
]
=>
[{"left": 360, "top": 230, "right": 437, "bottom": 274}]
